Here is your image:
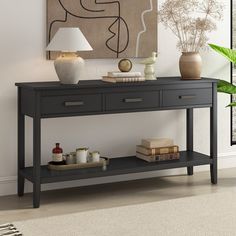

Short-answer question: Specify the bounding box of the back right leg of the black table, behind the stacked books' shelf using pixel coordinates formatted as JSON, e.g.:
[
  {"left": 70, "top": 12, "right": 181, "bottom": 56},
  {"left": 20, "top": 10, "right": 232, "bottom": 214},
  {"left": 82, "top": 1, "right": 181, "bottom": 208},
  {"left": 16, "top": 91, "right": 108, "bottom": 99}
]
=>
[{"left": 186, "top": 108, "right": 193, "bottom": 175}]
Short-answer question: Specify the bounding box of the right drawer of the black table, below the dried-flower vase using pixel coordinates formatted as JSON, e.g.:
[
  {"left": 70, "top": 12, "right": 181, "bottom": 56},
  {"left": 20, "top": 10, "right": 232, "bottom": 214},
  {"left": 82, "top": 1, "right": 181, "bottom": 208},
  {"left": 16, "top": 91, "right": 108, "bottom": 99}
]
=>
[{"left": 163, "top": 88, "right": 212, "bottom": 107}]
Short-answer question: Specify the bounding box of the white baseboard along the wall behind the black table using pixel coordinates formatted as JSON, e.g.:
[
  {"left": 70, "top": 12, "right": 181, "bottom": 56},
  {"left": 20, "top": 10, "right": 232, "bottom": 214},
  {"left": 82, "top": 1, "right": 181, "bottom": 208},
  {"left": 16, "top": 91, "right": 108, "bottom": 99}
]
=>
[{"left": 0, "top": 152, "right": 236, "bottom": 196}]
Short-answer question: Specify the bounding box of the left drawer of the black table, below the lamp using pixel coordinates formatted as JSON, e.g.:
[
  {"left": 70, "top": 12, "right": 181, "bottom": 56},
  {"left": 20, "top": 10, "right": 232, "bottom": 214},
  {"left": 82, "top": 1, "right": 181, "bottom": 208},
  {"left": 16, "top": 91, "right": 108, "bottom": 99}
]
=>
[{"left": 41, "top": 94, "right": 102, "bottom": 115}]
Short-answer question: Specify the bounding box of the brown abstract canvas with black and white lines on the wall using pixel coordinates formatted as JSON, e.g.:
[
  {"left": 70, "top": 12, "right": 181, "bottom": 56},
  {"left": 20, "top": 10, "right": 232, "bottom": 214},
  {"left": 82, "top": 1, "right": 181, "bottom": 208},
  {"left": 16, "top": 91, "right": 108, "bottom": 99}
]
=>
[{"left": 47, "top": 0, "right": 157, "bottom": 59}]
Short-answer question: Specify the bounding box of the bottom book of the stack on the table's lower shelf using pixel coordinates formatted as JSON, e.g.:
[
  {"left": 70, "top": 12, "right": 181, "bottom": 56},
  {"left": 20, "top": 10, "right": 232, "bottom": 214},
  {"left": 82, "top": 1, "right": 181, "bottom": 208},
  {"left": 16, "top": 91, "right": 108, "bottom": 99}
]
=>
[{"left": 136, "top": 152, "right": 180, "bottom": 162}]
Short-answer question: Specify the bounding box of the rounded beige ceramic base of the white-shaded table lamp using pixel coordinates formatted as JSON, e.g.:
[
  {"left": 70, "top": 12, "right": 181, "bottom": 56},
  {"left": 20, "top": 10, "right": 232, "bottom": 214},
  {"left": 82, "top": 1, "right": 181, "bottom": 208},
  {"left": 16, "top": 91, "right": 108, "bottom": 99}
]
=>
[{"left": 54, "top": 54, "right": 84, "bottom": 84}]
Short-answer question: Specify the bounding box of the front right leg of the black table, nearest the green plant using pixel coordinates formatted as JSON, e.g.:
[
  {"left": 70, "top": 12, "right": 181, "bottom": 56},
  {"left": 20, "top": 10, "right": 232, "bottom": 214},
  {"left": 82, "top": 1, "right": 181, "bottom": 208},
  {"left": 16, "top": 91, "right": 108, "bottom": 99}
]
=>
[{"left": 210, "top": 83, "right": 217, "bottom": 184}]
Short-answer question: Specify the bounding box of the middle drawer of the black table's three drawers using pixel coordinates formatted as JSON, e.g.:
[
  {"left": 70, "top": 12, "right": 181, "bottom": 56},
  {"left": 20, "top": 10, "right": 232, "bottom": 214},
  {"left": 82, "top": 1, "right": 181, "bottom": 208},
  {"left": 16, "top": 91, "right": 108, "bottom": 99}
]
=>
[{"left": 106, "top": 91, "right": 160, "bottom": 111}]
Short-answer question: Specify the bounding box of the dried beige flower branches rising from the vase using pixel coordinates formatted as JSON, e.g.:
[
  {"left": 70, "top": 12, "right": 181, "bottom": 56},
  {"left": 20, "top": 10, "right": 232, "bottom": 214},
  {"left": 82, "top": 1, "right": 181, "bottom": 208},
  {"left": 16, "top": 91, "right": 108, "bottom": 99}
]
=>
[{"left": 158, "top": 0, "right": 224, "bottom": 52}]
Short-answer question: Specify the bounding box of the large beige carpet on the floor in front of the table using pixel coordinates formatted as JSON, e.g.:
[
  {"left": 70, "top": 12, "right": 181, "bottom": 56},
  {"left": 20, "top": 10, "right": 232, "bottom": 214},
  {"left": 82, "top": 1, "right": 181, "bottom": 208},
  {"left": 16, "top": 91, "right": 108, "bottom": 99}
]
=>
[{"left": 14, "top": 189, "right": 236, "bottom": 236}]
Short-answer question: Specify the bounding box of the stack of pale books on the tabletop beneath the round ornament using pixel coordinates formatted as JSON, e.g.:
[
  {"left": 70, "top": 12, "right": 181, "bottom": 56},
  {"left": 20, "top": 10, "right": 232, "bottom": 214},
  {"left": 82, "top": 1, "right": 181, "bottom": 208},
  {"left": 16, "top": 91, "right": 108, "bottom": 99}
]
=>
[{"left": 102, "top": 71, "right": 145, "bottom": 83}]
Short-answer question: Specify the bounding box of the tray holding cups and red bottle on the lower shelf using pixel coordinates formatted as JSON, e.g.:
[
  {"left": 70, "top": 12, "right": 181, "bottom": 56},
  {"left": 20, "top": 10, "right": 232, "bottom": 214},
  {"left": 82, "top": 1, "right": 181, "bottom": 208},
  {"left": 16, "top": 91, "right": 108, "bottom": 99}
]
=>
[{"left": 48, "top": 157, "right": 109, "bottom": 170}]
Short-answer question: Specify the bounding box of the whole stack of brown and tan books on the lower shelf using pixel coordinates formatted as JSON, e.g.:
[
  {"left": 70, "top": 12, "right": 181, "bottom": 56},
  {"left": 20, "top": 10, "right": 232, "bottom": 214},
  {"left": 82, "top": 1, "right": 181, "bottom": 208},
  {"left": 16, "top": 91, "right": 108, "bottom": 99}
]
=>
[{"left": 136, "top": 138, "right": 180, "bottom": 162}]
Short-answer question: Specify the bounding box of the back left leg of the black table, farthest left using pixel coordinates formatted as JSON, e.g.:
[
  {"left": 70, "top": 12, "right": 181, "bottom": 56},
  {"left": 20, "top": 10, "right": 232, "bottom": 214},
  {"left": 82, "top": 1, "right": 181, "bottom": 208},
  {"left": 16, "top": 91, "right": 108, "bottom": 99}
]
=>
[{"left": 17, "top": 88, "right": 25, "bottom": 197}]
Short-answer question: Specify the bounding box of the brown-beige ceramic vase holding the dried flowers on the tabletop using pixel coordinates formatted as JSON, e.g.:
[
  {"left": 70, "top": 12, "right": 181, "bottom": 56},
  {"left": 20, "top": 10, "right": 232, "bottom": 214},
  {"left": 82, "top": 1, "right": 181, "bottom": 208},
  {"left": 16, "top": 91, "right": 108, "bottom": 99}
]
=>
[{"left": 179, "top": 52, "right": 202, "bottom": 80}]
